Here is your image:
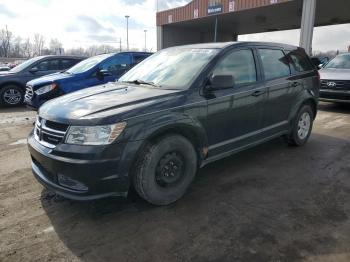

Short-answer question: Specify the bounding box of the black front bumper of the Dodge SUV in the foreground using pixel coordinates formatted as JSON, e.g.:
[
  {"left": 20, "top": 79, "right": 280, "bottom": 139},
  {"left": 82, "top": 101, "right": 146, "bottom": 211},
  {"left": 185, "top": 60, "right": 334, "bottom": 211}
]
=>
[{"left": 28, "top": 133, "right": 141, "bottom": 200}]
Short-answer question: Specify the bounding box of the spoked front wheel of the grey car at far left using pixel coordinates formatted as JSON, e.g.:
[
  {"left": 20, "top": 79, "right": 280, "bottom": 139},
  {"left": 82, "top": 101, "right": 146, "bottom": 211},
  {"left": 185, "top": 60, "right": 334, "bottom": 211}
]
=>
[{"left": 0, "top": 85, "right": 24, "bottom": 107}]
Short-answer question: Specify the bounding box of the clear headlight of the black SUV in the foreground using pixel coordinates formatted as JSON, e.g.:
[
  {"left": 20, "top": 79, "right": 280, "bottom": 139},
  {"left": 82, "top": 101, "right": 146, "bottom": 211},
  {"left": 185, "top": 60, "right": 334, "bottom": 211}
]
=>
[{"left": 66, "top": 122, "right": 126, "bottom": 145}]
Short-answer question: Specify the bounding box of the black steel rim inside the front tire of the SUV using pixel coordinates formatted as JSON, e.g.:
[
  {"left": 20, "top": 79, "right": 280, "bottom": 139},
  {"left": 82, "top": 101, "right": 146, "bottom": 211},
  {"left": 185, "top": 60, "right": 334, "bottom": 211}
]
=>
[{"left": 156, "top": 152, "right": 184, "bottom": 187}]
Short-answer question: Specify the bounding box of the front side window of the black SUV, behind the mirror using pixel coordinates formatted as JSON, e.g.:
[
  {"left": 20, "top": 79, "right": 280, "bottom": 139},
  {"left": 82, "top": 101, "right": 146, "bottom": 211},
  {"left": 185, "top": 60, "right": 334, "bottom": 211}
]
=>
[{"left": 213, "top": 50, "right": 256, "bottom": 84}]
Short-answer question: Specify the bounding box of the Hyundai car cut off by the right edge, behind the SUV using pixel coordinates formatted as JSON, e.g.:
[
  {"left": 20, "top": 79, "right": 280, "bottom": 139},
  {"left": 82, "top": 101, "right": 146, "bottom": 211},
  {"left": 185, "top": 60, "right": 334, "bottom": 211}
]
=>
[{"left": 319, "top": 53, "right": 350, "bottom": 103}]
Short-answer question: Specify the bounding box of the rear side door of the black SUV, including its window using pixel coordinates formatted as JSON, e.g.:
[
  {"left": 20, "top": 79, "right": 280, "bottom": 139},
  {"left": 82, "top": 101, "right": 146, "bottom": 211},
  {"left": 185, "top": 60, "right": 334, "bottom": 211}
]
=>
[{"left": 258, "top": 47, "right": 301, "bottom": 136}]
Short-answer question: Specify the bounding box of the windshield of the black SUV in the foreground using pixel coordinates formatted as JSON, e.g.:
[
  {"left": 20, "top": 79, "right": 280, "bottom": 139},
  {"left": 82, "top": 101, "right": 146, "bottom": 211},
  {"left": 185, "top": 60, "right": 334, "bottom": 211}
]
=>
[{"left": 119, "top": 47, "right": 218, "bottom": 89}]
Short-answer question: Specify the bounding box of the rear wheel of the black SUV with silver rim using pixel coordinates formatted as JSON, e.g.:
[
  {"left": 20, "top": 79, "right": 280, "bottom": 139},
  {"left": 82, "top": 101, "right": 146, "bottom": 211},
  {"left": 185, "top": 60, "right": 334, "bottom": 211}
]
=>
[{"left": 287, "top": 104, "right": 314, "bottom": 146}]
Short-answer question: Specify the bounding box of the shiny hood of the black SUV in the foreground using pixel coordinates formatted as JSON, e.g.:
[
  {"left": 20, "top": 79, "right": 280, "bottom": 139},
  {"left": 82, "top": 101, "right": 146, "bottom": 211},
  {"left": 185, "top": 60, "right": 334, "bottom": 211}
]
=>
[{"left": 39, "top": 83, "right": 184, "bottom": 125}]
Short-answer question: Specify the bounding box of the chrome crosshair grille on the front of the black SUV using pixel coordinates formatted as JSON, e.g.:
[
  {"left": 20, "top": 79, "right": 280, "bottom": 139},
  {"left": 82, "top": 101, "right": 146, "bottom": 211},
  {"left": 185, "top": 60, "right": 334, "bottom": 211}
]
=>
[{"left": 34, "top": 117, "right": 68, "bottom": 148}]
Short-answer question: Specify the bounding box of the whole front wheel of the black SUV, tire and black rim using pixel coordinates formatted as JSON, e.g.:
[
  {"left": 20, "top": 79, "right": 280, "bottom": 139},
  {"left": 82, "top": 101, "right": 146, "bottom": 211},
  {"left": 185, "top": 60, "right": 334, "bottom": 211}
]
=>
[{"left": 133, "top": 134, "right": 197, "bottom": 205}]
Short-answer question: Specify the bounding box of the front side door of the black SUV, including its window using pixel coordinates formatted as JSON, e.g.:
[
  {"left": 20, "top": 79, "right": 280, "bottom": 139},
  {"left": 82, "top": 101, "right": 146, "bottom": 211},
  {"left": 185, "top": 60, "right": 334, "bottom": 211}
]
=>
[{"left": 208, "top": 49, "right": 267, "bottom": 157}]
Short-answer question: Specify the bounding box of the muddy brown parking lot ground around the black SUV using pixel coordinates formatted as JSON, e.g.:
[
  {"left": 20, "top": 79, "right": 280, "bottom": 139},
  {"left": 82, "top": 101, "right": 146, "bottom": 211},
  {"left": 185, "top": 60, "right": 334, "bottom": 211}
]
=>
[{"left": 0, "top": 103, "right": 350, "bottom": 261}]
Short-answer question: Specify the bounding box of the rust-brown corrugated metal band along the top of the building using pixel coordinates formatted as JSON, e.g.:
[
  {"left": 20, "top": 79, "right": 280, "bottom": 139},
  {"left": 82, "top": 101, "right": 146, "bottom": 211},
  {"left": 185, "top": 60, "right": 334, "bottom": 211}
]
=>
[{"left": 157, "top": 0, "right": 293, "bottom": 26}]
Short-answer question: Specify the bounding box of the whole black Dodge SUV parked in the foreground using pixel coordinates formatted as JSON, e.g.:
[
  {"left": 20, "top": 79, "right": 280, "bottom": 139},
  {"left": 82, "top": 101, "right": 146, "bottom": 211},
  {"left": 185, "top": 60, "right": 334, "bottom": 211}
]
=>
[{"left": 28, "top": 42, "right": 320, "bottom": 205}]
